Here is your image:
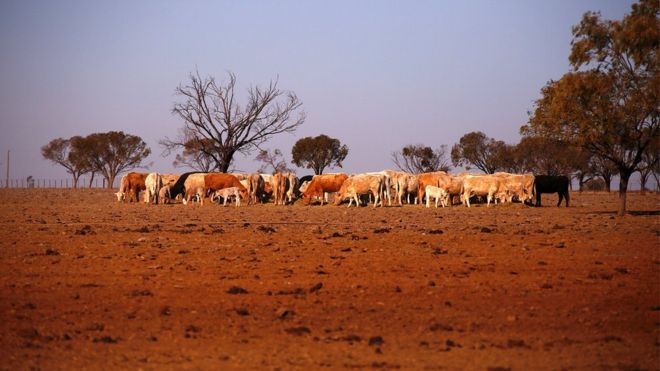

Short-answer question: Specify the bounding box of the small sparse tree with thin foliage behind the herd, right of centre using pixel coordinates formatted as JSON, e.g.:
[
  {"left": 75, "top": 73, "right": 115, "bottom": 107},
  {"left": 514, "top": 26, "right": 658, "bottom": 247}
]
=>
[{"left": 392, "top": 144, "right": 451, "bottom": 174}]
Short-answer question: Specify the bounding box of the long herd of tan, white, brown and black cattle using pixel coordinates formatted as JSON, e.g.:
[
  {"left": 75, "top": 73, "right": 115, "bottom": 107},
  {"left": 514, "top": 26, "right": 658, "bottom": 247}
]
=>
[{"left": 116, "top": 170, "right": 569, "bottom": 207}]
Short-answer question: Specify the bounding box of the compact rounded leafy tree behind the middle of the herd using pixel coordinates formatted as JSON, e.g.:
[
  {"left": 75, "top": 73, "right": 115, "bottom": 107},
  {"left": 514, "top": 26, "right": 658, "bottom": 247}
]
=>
[{"left": 291, "top": 134, "right": 348, "bottom": 175}]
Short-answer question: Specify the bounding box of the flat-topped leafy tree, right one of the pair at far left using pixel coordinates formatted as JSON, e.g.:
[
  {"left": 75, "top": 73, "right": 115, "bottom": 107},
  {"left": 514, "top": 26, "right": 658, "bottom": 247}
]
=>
[{"left": 83, "top": 131, "right": 151, "bottom": 188}]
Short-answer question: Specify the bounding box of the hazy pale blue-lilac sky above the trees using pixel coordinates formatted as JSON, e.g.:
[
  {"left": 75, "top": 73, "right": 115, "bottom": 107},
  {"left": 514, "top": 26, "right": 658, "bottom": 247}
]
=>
[{"left": 0, "top": 0, "right": 632, "bottom": 183}]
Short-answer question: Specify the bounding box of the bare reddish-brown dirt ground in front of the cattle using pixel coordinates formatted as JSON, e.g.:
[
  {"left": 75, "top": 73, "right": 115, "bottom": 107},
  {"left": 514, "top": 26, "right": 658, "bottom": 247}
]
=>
[{"left": 0, "top": 189, "right": 660, "bottom": 370}]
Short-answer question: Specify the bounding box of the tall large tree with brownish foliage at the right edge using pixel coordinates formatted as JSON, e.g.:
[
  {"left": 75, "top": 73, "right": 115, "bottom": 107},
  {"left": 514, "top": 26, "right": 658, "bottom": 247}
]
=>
[{"left": 521, "top": 0, "right": 660, "bottom": 215}]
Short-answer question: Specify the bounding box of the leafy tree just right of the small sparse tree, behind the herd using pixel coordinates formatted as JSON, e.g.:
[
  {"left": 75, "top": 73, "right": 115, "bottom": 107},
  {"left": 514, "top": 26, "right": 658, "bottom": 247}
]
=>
[{"left": 451, "top": 131, "right": 505, "bottom": 174}]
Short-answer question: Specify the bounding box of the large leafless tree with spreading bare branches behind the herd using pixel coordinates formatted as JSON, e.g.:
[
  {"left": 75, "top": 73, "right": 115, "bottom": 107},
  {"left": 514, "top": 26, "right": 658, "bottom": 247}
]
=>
[{"left": 160, "top": 72, "right": 305, "bottom": 172}]
